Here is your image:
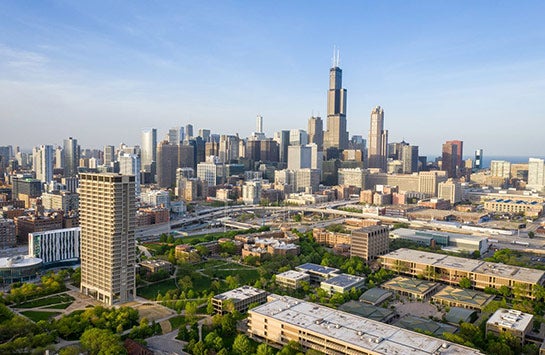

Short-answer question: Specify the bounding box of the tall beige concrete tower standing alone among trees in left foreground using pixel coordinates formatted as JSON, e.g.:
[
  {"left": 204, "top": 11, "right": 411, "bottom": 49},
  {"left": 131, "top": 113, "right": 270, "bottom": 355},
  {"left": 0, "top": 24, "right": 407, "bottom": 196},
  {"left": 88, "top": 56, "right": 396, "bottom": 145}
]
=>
[{"left": 79, "top": 173, "right": 136, "bottom": 305}]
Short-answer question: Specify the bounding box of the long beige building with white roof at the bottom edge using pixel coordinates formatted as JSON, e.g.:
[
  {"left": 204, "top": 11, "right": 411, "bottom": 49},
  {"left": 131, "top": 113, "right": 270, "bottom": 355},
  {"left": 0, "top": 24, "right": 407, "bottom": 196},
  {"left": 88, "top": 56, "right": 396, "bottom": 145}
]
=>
[{"left": 248, "top": 295, "right": 479, "bottom": 355}]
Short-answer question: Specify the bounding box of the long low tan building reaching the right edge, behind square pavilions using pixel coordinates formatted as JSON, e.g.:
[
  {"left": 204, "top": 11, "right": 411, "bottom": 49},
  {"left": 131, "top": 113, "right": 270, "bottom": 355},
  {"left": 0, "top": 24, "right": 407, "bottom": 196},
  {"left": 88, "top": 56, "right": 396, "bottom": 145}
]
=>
[{"left": 380, "top": 248, "right": 545, "bottom": 299}]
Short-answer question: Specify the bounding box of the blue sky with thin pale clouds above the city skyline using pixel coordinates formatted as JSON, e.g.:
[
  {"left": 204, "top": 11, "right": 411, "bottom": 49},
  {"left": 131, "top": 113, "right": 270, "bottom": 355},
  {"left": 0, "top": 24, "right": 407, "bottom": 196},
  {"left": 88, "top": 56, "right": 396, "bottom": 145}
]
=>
[{"left": 0, "top": 0, "right": 545, "bottom": 156}]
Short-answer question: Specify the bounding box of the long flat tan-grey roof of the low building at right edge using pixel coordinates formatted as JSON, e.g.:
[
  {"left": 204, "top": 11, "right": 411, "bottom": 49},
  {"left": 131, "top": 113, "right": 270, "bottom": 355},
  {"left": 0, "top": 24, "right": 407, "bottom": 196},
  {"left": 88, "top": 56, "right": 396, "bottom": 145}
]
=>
[{"left": 382, "top": 248, "right": 545, "bottom": 283}]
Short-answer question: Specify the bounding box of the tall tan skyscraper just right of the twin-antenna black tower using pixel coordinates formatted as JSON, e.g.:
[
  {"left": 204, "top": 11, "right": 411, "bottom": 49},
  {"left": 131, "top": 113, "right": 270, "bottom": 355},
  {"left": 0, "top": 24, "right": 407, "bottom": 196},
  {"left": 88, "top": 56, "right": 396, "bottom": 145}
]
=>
[{"left": 368, "top": 106, "right": 388, "bottom": 171}]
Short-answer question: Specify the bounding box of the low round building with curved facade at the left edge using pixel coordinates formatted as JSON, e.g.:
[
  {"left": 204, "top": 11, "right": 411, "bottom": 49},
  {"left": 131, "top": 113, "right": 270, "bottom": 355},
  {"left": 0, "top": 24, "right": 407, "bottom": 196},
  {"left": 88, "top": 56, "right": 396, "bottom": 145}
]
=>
[{"left": 0, "top": 255, "right": 42, "bottom": 284}]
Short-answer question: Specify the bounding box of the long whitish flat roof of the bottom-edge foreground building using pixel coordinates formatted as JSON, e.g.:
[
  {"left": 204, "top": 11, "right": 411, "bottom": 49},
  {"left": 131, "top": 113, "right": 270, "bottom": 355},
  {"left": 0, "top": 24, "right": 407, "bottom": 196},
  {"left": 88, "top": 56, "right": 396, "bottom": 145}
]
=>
[{"left": 249, "top": 296, "right": 480, "bottom": 355}]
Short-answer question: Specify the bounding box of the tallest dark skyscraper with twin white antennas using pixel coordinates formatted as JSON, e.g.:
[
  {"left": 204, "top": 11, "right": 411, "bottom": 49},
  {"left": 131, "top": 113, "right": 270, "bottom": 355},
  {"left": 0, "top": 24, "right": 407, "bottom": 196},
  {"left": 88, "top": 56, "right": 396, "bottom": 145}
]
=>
[{"left": 324, "top": 53, "right": 348, "bottom": 149}]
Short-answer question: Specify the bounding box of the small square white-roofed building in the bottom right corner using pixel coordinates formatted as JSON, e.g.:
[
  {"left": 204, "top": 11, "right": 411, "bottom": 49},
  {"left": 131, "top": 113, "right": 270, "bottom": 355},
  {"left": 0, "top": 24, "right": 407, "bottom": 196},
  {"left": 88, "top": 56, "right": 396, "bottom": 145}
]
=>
[{"left": 486, "top": 308, "right": 534, "bottom": 344}]
